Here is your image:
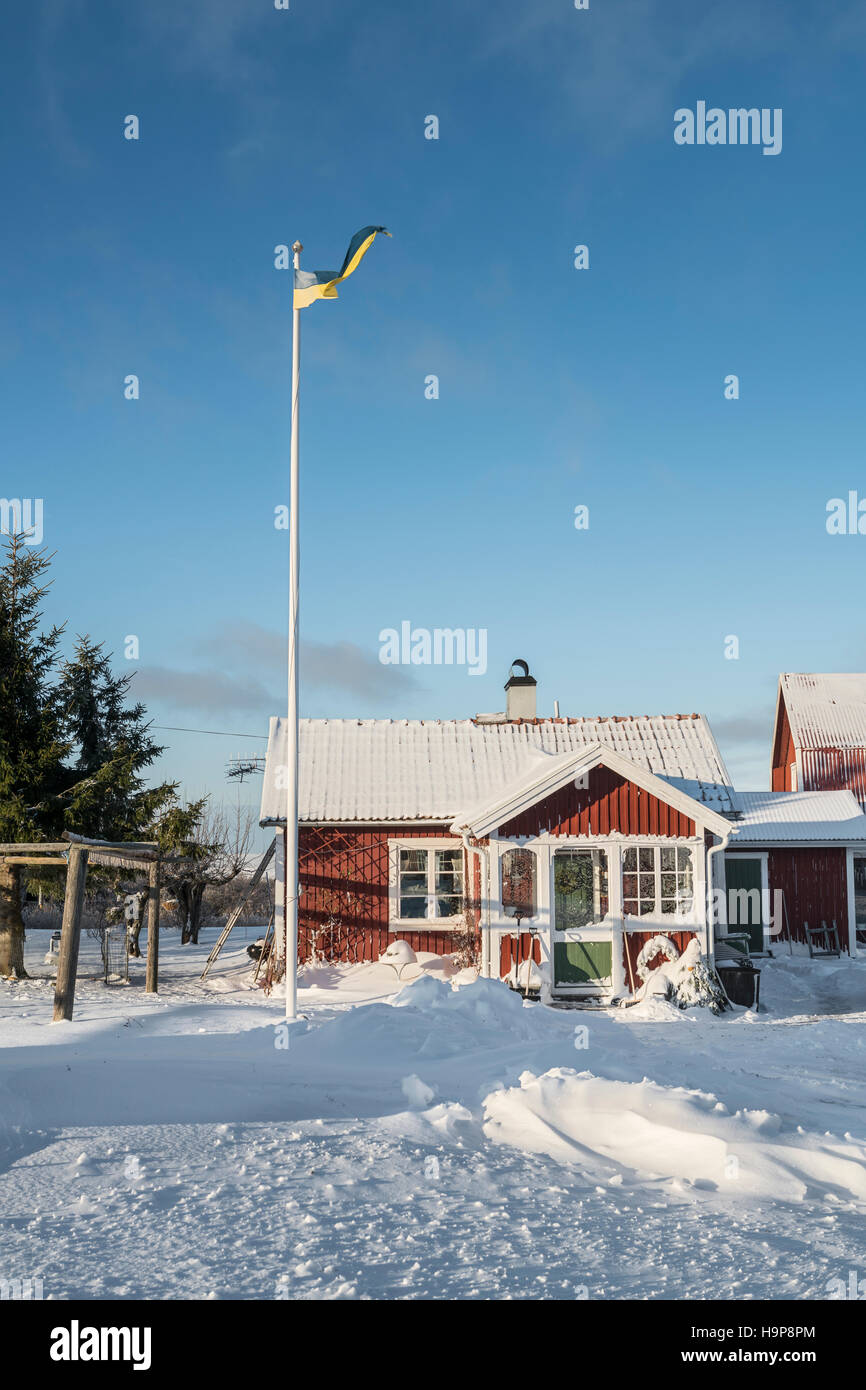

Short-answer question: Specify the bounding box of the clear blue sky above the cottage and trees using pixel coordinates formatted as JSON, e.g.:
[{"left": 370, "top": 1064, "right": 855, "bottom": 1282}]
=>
[{"left": 0, "top": 0, "right": 866, "bottom": 822}]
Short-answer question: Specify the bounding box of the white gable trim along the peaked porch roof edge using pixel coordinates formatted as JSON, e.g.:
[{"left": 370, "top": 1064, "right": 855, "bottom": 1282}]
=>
[{"left": 450, "top": 744, "right": 731, "bottom": 840}]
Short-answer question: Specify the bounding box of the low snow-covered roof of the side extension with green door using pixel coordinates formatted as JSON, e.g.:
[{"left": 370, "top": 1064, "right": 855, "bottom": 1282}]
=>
[{"left": 730, "top": 791, "right": 866, "bottom": 849}]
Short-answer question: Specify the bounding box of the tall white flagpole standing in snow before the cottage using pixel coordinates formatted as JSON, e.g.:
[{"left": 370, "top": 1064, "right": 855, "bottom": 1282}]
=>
[{"left": 285, "top": 242, "right": 303, "bottom": 1022}]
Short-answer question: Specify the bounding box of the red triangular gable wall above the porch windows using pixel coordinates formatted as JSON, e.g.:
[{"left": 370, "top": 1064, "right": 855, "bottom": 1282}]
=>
[{"left": 500, "top": 766, "right": 695, "bottom": 837}]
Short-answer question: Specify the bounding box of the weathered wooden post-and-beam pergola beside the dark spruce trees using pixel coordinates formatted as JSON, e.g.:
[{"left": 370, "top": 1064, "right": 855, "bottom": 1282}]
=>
[{"left": 0, "top": 830, "right": 175, "bottom": 1023}]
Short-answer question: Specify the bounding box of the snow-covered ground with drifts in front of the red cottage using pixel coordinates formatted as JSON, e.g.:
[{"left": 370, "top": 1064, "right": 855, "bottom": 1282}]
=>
[{"left": 0, "top": 929, "right": 866, "bottom": 1300}]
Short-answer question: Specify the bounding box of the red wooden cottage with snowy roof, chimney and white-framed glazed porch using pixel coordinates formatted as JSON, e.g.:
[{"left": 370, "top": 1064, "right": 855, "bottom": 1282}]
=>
[{"left": 261, "top": 663, "right": 866, "bottom": 999}]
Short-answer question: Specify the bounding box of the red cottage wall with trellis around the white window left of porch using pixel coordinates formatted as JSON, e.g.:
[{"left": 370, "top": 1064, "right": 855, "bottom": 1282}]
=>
[{"left": 291, "top": 824, "right": 481, "bottom": 962}]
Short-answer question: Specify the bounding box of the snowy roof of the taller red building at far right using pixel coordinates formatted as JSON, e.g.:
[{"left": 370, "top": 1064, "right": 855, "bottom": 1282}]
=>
[{"left": 778, "top": 671, "right": 866, "bottom": 749}]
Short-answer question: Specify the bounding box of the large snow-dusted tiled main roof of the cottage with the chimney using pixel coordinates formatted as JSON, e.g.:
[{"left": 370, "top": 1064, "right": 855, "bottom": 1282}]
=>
[{"left": 261, "top": 714, "right": 733, "bottom": 824}]
